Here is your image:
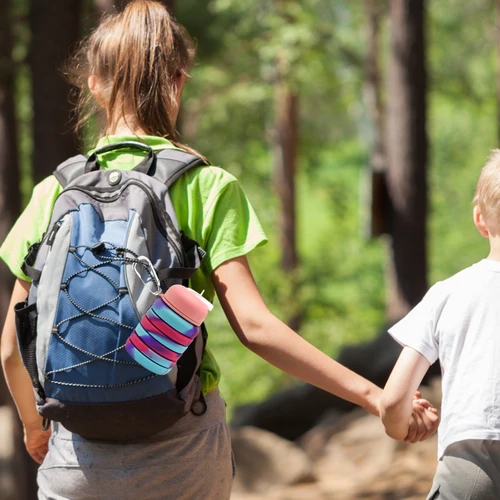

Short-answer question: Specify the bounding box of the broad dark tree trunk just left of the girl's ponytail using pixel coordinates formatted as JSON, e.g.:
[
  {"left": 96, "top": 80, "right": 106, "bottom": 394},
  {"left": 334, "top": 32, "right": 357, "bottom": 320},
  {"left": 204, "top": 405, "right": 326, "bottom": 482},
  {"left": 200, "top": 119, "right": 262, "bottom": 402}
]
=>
[{"left": 29, "top": 0, "right": 82, "bottom": 183}]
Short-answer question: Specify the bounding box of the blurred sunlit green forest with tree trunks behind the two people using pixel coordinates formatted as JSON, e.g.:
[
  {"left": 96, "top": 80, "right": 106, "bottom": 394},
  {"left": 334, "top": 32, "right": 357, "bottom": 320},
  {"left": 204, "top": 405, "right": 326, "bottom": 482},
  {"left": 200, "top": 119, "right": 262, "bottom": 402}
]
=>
[{"left": 0, "top": 0, "right": 499, "bottom": 498}]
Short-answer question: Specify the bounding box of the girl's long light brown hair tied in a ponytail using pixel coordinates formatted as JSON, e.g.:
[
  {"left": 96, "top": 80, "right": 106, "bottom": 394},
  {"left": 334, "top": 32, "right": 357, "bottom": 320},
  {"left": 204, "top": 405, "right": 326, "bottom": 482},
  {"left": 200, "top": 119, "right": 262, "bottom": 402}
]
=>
[{"left": 66, "top": 0, "right": 198, "bottom": 154}]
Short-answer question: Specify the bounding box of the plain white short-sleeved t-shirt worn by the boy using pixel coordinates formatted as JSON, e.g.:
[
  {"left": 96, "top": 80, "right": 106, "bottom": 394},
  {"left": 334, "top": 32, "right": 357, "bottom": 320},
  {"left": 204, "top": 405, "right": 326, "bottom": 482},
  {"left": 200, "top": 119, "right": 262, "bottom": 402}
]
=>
[{"left": 389, "top": 260, "right": 500, "bottom": 458}]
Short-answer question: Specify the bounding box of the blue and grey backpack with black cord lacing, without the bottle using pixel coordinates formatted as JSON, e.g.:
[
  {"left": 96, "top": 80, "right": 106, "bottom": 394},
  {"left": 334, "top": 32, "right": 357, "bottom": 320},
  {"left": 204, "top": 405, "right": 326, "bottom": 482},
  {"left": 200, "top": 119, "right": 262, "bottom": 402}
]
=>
[{"left": 15, "top": 142, "right": 206, "bottom": 441}]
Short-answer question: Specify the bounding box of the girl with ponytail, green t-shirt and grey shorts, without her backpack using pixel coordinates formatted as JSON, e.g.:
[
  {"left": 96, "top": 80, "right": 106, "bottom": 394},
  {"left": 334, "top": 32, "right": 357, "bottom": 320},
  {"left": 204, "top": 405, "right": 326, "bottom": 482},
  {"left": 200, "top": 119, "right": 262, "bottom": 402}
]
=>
[{"left": 0, "top": 0, "right": 436, "bottom": 500}]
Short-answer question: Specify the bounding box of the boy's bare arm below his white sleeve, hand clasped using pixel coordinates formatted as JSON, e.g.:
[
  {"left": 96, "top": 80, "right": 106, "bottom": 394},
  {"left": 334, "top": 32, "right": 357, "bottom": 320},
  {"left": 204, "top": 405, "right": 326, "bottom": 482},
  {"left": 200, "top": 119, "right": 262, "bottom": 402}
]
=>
[{"left": 380, "top": 347, "right": 437, "bottom": 442}]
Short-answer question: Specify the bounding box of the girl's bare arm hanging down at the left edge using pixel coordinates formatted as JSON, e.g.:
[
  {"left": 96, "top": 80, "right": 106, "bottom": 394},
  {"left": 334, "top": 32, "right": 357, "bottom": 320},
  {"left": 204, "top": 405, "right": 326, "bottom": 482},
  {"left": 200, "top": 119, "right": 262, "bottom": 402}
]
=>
[{"left": 0, "top": 279, "right": 50, "bottom": 463}]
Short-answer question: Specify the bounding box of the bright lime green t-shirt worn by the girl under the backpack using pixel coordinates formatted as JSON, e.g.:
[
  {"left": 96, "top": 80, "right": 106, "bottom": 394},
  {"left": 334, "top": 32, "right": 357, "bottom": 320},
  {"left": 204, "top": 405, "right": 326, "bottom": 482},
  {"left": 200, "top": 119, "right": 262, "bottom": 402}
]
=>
[{"left": 0, "top": 136, "right": 267, "bottom": 393}]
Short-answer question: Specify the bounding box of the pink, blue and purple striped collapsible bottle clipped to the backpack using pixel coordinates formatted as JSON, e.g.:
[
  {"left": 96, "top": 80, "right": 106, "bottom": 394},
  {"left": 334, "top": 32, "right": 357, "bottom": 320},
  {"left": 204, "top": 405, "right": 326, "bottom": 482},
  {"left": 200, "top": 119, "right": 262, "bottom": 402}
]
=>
[{"left": 125, "top": 285, "right": 213, "bottom": 375}]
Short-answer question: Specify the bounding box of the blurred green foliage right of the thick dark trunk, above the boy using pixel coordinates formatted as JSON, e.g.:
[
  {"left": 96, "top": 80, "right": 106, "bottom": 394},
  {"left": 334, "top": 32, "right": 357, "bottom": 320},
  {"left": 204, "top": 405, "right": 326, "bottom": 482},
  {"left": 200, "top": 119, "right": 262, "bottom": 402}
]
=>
[{"left": 428, "top": 0, "right": 499, "bottom": 283}]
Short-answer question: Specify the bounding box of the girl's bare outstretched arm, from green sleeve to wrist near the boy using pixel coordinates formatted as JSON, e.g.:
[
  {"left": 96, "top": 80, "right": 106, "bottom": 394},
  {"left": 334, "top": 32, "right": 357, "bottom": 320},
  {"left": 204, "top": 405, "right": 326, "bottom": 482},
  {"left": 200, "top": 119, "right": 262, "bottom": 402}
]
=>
[{"left": 212, "top": 257, "right": 380, "bottom": 418}]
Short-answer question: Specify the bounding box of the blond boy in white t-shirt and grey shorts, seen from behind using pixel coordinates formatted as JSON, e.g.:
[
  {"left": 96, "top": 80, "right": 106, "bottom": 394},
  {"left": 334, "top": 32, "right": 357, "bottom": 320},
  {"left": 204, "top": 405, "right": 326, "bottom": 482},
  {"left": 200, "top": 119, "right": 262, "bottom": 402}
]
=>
[{"left": 380, "top": 149, "right": 500, "bottom": 500}]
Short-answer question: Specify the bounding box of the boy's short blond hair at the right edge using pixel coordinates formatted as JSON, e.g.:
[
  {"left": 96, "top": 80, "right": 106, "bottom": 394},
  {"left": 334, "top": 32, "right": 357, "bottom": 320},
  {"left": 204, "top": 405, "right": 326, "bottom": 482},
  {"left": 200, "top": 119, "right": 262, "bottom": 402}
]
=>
[{"left": 472, "top": 149, "right": 500, "bottom": 236}]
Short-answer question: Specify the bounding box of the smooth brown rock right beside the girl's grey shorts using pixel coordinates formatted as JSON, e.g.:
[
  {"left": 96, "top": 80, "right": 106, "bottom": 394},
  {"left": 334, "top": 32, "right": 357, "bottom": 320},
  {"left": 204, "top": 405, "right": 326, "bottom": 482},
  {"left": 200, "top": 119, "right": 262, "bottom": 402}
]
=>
[{"left": 231, "top": 427, "right": 315, "bottom": 493}]
